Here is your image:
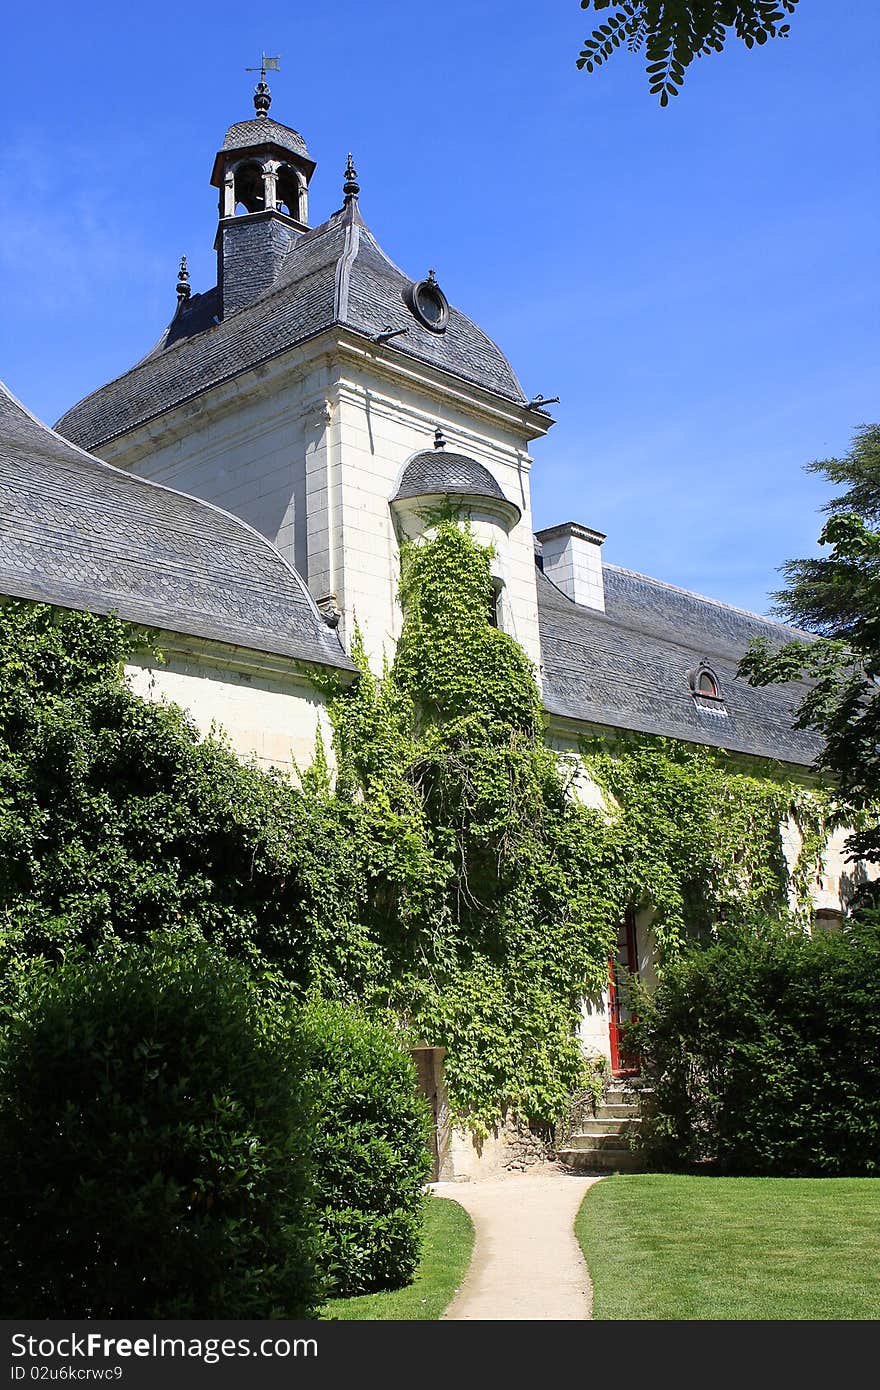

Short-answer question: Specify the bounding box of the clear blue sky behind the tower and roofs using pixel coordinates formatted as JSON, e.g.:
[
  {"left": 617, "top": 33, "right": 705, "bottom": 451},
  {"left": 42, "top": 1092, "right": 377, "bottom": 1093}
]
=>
[{"left": 0, "top": 0, "right": 880, "bottom": 612}]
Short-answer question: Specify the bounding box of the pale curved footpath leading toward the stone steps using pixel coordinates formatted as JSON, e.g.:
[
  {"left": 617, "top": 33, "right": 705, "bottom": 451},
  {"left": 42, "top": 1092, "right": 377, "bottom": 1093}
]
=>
[{"left": 432, "top": 1169, "right": 601, "bottom": 1322}]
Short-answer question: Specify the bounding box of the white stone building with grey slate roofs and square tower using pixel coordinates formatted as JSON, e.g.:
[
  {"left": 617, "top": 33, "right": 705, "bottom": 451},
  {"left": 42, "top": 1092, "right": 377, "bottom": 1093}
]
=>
[{"left": 0, "top": 81, "right": 845, "bottom": 1173}]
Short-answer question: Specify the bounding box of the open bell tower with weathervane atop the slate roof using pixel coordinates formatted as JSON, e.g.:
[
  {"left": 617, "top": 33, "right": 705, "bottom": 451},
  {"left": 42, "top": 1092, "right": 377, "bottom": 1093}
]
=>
[{"left": 211, "top": 67, "right": 316, "bottom": 318}]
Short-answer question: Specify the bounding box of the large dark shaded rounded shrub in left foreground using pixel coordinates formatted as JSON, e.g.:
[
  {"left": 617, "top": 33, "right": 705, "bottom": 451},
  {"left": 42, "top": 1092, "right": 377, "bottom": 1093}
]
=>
[{"left": 0, "top": 938, "right": 320, "bottom": 1318}]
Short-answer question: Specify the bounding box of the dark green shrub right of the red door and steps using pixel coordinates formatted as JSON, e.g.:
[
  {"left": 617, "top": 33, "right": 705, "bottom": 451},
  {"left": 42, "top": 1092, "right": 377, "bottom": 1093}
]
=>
[{"left": 634, "top": 926, "right": 880, "bottom": 1176}]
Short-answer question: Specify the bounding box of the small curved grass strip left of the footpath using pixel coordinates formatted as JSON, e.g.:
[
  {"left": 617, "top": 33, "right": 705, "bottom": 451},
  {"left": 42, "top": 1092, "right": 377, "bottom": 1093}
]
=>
[{"left": 320, "top": 1197, "right": 474, "bottom": 1322}]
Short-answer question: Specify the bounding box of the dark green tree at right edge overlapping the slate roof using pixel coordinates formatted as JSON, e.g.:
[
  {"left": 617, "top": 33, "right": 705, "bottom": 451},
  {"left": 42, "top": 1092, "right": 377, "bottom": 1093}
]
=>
[{"left": 740, "top": 425, "right": 880, "bottom": 862}]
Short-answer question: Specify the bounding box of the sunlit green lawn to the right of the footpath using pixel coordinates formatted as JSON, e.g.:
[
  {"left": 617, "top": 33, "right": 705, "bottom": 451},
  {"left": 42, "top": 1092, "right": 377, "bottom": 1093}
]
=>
[{"left": 576, "top": 1173, "right": 880, "bottom": 1321}]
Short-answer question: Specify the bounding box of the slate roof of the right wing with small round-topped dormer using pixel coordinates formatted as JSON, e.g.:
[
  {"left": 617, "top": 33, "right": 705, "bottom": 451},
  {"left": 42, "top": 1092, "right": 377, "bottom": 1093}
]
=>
[{"left": 537, "top": 564, "right": 822, "bottom": 766}]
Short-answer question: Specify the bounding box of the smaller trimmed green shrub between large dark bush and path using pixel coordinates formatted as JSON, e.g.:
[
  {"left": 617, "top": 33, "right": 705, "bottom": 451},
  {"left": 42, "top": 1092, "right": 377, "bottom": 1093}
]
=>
[{"left": 304, "top": 1002, "right": 430, "bottom": 1295}]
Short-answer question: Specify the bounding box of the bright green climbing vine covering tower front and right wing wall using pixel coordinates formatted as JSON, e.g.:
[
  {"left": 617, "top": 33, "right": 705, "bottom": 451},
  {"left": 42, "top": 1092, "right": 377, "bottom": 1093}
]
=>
[{"left": 323, "top": 517, "right": 826, "bottom": 1133}]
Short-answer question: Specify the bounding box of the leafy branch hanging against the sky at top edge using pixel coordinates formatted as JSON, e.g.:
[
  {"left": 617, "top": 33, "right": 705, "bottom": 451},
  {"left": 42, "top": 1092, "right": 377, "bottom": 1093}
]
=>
[{"left": 577, "top": 0, "right": 798, "bottom": 106}]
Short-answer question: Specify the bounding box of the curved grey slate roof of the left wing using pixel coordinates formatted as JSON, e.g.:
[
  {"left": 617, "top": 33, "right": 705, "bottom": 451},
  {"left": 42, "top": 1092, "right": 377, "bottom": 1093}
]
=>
[{"left": 0, "top": 382, "right": 355, "bottom": 670}]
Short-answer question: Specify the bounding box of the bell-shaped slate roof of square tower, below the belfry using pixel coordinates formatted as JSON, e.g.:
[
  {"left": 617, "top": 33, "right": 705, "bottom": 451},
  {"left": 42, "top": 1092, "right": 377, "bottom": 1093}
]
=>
[{"left": 57, "top": 198, "right": 525, "bottom": 449}]
